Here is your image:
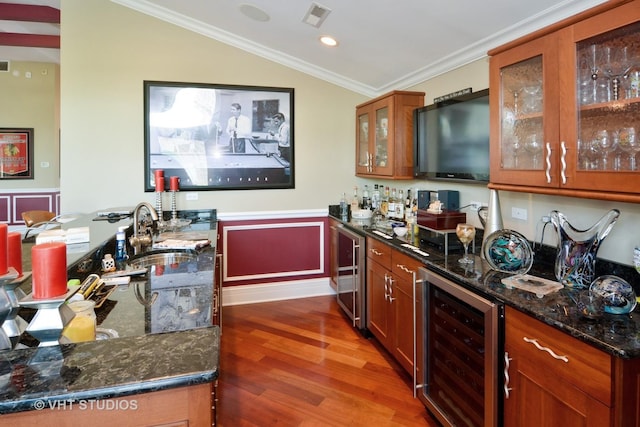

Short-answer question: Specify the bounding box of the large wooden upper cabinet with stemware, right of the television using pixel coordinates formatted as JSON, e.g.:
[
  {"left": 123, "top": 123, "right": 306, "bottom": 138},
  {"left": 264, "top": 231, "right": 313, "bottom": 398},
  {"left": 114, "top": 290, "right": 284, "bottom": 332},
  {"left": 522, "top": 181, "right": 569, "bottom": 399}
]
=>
[{"left": 490, "top": 1, "right": 640, "bottom": 202}]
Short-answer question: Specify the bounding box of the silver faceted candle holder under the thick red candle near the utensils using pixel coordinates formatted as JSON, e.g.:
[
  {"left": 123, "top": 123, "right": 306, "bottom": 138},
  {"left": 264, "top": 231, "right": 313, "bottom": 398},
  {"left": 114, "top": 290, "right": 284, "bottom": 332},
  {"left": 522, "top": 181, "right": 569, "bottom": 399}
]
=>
[{"left": 20, "top": 287, "right": 79, "bottom": 347}]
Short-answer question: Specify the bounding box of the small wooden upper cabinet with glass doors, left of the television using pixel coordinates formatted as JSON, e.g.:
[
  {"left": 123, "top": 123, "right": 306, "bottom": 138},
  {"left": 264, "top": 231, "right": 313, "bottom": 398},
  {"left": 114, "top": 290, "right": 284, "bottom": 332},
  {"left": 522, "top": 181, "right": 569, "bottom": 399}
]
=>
[{"left": 356, "top": 91, "right": 424, "bottom": 179}]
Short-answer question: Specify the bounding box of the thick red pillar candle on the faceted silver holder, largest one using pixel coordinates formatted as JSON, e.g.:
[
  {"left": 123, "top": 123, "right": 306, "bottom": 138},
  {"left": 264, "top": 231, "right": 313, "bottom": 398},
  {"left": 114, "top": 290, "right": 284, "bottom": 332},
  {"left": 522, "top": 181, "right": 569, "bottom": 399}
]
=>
[{"left": 31, "top": 242, "right": 67, "bottom": 299}]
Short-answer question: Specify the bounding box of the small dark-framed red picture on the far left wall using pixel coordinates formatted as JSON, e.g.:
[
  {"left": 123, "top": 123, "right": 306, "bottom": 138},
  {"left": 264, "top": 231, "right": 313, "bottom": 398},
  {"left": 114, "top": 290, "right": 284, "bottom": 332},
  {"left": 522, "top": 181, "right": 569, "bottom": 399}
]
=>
[{"left": 0, "top": 128, "right": 33, "bottom": 179}]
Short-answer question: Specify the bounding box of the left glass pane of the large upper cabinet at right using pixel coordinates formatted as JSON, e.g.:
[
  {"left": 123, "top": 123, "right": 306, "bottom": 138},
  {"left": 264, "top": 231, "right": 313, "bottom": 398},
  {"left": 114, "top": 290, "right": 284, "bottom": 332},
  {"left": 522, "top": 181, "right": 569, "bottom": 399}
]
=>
[{"left": 500, "top": 55, "right": 544, "bottom": 170}]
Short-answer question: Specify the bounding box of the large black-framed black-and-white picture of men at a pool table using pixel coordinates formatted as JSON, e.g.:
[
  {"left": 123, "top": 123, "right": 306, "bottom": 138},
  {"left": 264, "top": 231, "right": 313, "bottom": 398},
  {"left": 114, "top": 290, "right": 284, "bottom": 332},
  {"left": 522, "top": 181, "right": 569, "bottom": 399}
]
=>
[{"left": 144, "top": 81, "right": 294, "bottom": 191}]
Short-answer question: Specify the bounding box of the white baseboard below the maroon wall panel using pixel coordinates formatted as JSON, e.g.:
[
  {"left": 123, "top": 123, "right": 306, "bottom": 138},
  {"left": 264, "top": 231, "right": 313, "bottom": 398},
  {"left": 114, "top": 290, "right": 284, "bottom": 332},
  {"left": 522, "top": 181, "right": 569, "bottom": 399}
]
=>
[{"left": 222, "top": 277, "right": 335, "bottom": 306}]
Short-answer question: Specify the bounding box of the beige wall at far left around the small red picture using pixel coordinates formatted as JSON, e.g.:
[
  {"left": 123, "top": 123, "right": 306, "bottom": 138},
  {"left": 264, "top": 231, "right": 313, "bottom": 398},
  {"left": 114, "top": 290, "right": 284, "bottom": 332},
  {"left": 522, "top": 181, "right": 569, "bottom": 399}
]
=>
[{"left": 0, "top": 61, "right": 60, "bottom": 191}]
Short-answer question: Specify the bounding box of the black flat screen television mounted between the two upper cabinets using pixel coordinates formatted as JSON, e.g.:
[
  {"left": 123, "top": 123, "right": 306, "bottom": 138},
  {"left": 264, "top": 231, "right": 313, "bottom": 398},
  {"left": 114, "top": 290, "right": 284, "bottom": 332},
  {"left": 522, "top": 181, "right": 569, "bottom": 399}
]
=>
[{"left": 413, "top": 89, "right": 489, "bottom": 183}]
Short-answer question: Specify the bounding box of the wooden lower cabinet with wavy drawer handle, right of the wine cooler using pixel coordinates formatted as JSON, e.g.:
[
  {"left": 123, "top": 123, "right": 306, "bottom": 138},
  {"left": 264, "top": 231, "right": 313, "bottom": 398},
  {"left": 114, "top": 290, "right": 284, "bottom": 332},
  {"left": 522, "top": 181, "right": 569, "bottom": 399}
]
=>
[{"left": 504, "top": 307, "right": 612, "bottom": 427}]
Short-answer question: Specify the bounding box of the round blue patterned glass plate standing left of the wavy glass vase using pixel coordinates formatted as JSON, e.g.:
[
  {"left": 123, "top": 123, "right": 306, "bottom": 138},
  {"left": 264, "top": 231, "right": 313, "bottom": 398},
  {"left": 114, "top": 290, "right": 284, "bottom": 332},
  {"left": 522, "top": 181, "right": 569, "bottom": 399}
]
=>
[{"left": 482, "top": 230, "right": 533, "bottom": 274}]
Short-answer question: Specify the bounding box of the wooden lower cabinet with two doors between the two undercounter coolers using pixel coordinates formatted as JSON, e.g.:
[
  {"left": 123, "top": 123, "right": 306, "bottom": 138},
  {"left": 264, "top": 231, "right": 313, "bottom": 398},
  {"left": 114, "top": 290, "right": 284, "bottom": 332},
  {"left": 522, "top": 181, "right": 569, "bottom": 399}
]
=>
[{"left": 367, "top": 238, "right": 422, "bottom": 376}]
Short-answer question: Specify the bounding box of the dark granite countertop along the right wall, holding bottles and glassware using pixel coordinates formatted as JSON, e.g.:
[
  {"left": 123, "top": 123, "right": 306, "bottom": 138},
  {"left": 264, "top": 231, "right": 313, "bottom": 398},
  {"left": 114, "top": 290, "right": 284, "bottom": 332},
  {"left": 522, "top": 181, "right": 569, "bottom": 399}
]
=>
[{"left": 329, "top": 208, "right": 640, "bottom": 359}]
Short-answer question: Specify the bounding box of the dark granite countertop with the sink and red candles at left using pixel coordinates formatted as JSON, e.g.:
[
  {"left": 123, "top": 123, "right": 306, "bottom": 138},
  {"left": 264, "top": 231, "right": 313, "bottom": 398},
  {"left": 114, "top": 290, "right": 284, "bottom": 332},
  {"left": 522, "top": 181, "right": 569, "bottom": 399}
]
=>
[{"left": 0, "top": 210, "right": 220, "bottom": 414}]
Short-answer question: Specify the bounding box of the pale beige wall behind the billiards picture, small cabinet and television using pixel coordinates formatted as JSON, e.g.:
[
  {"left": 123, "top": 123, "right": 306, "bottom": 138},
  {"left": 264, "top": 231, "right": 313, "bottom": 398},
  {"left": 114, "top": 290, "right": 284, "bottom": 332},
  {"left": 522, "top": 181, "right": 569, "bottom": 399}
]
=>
[{"left": 61, "top": 0, "right": 640, "bottom": 264}]
